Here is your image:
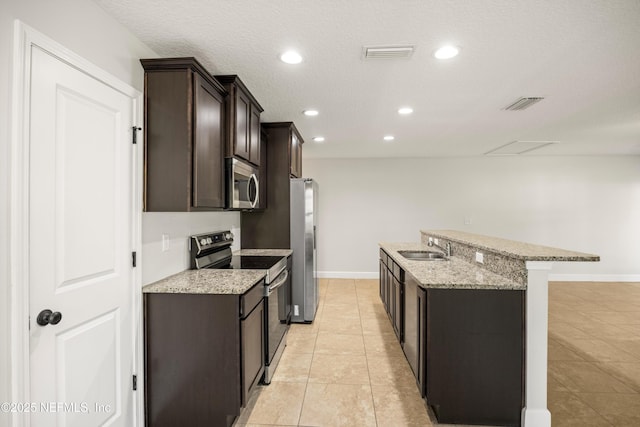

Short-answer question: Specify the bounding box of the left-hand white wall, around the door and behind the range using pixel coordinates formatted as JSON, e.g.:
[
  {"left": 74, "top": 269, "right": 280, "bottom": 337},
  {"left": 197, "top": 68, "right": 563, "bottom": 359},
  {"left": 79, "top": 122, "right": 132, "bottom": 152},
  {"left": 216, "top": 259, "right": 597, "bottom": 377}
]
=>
[{"left": 0, "top": 0, "right": 240, "bottom": 427}]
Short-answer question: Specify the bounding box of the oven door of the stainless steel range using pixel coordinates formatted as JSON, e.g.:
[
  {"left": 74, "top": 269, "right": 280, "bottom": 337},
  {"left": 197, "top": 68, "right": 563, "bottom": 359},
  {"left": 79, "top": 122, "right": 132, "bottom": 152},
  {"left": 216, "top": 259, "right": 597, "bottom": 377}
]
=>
[{"left": 265, "top": 269, "right": 291, "bottom": 365}]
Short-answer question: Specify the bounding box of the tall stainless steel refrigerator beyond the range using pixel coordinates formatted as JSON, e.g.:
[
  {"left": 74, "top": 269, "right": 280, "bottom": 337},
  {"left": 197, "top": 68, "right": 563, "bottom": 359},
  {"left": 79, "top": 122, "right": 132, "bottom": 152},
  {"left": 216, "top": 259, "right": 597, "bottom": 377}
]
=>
[{"left": 289, "top": 178, "right": 320, "bottom": 323}]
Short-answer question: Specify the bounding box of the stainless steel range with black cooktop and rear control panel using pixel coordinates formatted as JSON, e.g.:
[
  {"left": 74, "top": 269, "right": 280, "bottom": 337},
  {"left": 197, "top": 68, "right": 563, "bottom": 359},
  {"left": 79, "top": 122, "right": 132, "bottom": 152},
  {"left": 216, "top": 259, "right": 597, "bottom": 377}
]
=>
[{"left": 189, "top": 231, "right": 291, "bottom": 384}]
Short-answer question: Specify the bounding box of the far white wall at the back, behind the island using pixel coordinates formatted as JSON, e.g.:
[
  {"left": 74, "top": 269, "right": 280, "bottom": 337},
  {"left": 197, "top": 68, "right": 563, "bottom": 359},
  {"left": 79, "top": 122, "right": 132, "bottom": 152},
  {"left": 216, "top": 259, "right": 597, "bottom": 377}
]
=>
[{"left": 303, "top": 156, "right": 640, "bottom": 281}]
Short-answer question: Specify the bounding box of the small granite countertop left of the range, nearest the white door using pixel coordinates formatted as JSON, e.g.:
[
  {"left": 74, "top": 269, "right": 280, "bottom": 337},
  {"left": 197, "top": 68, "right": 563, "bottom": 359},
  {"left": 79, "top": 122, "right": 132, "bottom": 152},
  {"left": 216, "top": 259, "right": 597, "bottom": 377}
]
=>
[{"left": 142, "top": 269, "right": 266, "bottom": 295}]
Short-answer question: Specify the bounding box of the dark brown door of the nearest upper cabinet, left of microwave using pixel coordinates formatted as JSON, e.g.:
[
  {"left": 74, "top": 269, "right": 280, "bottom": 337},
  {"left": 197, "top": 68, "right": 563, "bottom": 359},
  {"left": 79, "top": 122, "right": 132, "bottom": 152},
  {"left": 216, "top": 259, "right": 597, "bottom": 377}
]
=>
[{"left": 192, "top": 74, "right": 224, "bottom": 208}]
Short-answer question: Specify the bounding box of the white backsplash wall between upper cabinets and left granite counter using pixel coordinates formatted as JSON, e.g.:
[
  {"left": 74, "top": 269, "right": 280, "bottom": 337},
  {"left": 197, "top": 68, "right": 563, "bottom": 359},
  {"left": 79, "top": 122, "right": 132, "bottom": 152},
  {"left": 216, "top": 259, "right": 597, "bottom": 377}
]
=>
[{"left": 139, "top": 212, "right": 240, "bottom": 286}]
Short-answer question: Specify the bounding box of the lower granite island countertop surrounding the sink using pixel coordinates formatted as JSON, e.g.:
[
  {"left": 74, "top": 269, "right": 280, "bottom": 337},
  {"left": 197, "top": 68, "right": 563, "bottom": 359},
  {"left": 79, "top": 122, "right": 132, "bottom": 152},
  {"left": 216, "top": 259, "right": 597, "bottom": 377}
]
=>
[{"left": 379, "top": 242, "right": 526, "bottom": 290}]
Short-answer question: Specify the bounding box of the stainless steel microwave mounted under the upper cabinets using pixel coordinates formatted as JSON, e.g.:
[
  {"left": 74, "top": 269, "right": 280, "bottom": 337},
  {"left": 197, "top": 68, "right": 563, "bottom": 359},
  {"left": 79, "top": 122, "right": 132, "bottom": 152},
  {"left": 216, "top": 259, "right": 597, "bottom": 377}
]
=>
[{"left": 225, "top": 157, "right": 260, "bottom": 209}]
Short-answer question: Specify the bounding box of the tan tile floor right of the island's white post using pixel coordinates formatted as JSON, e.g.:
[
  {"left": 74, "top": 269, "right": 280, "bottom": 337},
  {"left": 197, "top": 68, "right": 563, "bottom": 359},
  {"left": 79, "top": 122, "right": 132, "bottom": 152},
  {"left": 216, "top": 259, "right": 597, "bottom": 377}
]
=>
[{"left": 547, "top": 282, "right": 640, "bottom": 427}]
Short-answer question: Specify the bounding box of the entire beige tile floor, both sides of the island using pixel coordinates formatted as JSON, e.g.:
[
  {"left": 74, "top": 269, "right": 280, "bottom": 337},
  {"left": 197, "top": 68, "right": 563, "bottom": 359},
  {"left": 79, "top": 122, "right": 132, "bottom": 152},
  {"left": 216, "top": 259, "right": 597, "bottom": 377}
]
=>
[{"left": 235, "top": 279, "right": 640, "bottom": 427}]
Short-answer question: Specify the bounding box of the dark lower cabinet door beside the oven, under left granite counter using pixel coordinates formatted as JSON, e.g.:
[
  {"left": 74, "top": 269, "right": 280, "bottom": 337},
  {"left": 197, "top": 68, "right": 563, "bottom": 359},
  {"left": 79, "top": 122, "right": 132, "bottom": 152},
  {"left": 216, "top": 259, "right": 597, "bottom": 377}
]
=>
[{"left": 240, "top": 301, "right": 264, "bottom": 407}]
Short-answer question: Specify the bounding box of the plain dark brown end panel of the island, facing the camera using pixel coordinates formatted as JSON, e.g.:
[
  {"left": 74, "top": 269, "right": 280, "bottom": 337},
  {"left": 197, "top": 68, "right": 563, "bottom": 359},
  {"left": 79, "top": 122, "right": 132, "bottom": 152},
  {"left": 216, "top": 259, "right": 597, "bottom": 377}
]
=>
[{"left": 426, "top": 289, "right": 525, "bottom": 426}]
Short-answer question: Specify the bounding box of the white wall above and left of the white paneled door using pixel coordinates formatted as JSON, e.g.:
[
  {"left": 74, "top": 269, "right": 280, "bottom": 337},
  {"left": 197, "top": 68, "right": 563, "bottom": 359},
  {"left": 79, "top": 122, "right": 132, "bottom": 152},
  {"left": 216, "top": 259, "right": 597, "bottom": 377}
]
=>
[{"left": 0, "top": 0, "right": 155, "bottom": 427}]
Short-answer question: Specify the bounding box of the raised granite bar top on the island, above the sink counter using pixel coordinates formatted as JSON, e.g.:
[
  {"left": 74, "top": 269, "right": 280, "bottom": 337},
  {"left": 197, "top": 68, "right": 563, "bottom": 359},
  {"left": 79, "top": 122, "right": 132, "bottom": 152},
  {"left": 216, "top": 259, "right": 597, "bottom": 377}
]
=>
[{"left": 420, "top": 230, "right": 600, "bottom": 261}]
